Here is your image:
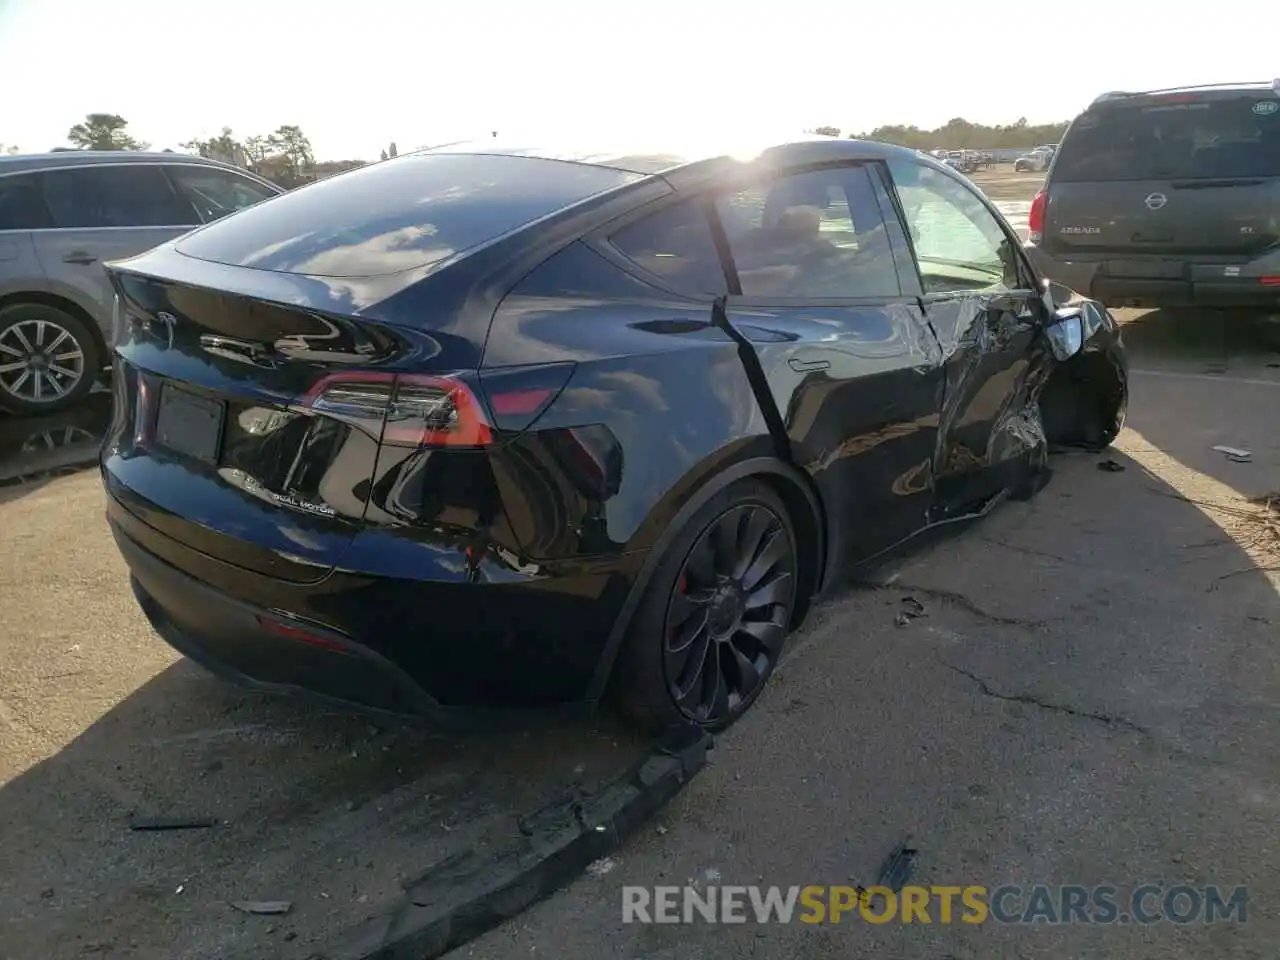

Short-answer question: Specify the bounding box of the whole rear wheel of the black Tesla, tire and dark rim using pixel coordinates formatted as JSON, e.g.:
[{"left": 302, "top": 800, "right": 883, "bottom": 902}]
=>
[{"left": 613, "top": 479, "right": 799, "bottom": 731}]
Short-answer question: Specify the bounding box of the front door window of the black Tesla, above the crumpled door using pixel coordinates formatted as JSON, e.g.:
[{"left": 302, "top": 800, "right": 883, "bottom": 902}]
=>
[{"left": 888, "top": 160, "right": 1021, "bottom": 293}]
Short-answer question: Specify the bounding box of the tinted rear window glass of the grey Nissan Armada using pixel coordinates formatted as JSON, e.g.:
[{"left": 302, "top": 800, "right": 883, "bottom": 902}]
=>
[{"left": 1053, "top": 95, "right": 1280, "bottom": 182}]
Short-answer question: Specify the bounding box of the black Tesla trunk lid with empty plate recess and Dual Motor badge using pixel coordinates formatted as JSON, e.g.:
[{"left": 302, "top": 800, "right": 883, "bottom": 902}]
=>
[{"left": 102, "top": 270, "right": 422, "bottom": 582}]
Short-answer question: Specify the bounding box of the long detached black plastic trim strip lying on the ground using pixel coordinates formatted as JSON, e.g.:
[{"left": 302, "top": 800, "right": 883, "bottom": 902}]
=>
[{"left": 330, "top": 727, "right": 714, "bottom": 960}]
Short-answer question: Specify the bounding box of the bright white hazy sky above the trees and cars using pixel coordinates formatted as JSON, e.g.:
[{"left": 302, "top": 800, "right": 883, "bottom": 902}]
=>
[{"left": 0, "top": 0, "right": 1280, "bottom": 160}]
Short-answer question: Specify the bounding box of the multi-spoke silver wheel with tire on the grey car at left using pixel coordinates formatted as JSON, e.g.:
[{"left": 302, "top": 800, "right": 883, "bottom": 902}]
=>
[{"left": 0, "top": 303, "right": 102, "bottom": 416}]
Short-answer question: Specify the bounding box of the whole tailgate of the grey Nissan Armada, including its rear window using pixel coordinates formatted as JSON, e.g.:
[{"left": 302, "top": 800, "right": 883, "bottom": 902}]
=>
[{"left": 1043, "top": 90, "right": 1280, "bottom": 259}]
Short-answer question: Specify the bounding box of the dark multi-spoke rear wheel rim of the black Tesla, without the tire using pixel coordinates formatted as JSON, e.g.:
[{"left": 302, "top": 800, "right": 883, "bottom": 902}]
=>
[{"left": 663, "top": 503, "right": 796, "bottom": 726}]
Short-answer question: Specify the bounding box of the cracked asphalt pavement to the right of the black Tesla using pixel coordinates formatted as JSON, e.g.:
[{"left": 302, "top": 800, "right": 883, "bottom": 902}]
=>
[{"left": 454, "top": 314, "right": 1280, "bottom": 960}]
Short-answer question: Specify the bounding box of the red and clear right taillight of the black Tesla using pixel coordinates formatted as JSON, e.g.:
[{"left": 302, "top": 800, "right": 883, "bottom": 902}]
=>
[{"left": 302, "top": 371, "right": 493, "bottom": 447}]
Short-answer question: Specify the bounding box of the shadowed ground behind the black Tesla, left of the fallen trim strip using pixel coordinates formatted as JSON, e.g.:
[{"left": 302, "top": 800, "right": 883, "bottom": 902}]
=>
[{"left": 0, "top": 660, "right": 648, "bottom": 957}]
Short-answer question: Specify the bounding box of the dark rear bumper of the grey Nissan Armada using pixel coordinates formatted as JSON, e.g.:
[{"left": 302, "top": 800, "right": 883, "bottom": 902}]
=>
[{"left": 1025, "top": 244, "right": 1280, "bottom": 312}]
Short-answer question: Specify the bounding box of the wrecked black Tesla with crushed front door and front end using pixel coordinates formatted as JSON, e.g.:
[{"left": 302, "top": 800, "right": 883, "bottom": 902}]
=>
[{"left": 101, "top": 137, "right": 1126, "bottom": 727}]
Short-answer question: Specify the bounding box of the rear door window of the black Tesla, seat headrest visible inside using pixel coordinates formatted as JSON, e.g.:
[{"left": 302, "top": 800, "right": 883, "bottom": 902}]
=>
[{"left": 716, "top": 166, "right": 901, "bottom": 300}]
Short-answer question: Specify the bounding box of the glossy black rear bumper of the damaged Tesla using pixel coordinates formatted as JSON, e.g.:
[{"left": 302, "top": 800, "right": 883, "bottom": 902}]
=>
[{"left": 108, "top": 493, "right": 643, "bottom": 730}]
